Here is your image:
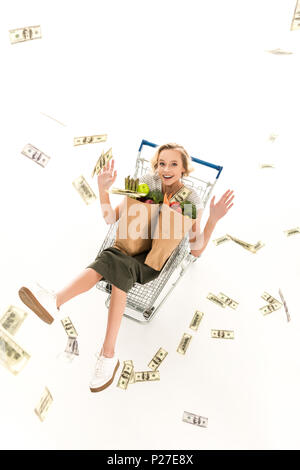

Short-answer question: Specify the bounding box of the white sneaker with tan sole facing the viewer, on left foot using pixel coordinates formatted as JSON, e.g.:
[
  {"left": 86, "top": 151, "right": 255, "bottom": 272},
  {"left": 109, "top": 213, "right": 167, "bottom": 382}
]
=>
[{"left": 19, "top": 282, "right": 59, "bottom": 324}]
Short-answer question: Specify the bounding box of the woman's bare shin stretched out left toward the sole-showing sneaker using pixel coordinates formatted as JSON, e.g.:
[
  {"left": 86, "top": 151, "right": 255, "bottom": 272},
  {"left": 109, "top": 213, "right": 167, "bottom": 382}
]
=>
[{"left": 56, "top": 268, "right": 103, "bottom": 308}]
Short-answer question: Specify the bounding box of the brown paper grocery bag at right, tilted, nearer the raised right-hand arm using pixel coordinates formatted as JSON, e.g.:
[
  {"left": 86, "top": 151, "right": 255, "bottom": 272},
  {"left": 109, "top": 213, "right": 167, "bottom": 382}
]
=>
[{"left": 144, "top": 204, "right": 195, "bottom": 271}]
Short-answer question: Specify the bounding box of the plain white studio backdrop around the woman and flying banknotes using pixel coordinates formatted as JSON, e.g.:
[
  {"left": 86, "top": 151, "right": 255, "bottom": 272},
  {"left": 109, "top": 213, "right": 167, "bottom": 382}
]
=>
[{"left": 0, "top": 0, "right": 300, "bottom": 449}]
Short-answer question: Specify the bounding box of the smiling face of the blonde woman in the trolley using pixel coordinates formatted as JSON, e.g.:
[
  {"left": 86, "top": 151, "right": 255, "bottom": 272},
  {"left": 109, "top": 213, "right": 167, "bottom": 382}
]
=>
[{"left": 157, "top": 149, "right": 185, "bottom": 186}]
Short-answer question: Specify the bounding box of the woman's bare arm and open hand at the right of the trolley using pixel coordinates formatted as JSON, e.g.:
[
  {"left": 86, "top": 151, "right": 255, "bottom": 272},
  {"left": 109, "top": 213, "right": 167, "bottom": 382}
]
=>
[{"left": 190, "top": 189, "right": 234, "bottom": 257}]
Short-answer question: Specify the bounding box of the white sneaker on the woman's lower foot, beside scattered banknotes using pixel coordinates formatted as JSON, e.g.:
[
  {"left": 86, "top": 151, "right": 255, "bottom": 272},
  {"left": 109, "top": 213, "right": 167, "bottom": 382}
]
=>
[{"left": 90, "top": 354, "right": 120, "bottom": 392}]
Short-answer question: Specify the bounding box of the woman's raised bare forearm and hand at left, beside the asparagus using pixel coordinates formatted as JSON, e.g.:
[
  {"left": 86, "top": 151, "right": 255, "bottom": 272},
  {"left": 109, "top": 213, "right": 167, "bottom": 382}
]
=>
[{"left": 98, "top": 159, "right": 122, "bottom": 224}]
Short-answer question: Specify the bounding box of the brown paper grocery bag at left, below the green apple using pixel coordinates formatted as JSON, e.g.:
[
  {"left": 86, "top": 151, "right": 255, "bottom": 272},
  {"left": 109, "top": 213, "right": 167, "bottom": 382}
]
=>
[{"left": 113, "top": 196, "right": 159, "bottom": 256}]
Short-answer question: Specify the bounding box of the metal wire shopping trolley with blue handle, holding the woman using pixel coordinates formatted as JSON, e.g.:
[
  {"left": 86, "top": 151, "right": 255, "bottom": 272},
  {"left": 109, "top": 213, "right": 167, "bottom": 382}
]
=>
[{"left": 96, "top": 140, "right": 223, "bottom": 323}]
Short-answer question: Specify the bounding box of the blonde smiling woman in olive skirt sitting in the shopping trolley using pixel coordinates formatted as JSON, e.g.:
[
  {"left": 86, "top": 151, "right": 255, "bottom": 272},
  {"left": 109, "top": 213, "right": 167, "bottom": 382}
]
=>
[{"left": 19, "top": 143, "right": 234, "bottom": 392}]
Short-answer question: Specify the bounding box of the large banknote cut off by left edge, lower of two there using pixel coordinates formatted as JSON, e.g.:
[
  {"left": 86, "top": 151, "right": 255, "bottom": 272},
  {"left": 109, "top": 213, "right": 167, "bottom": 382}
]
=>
[{"left": 0, "top": 328, "right": 30, "bottom": 375}]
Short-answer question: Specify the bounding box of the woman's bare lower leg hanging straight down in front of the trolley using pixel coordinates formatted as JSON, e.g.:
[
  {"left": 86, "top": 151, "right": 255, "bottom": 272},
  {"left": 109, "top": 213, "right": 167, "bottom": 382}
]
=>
[{"left": 101, "top": 285, "right": 127, "bottom": 357}]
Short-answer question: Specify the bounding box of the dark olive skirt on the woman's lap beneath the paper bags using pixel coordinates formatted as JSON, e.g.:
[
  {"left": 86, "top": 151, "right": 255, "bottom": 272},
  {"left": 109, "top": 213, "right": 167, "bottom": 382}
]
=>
[{"left": 86, "top": 247, "right": 160, "bottom": 292}]
